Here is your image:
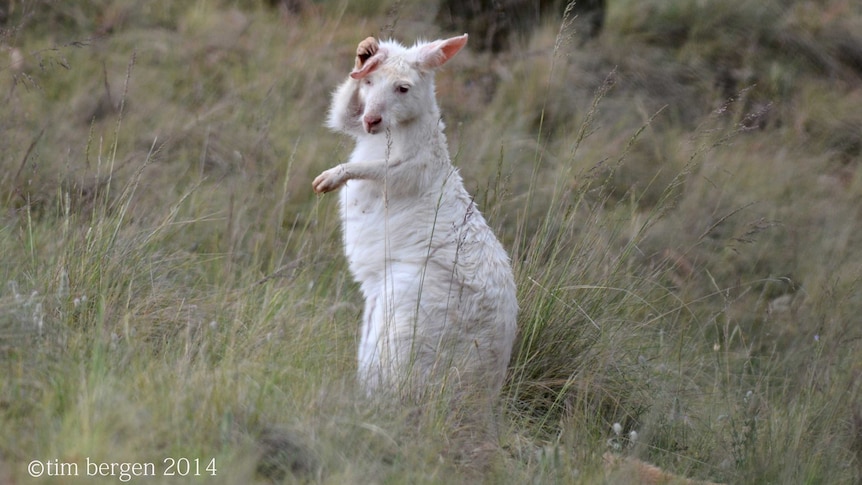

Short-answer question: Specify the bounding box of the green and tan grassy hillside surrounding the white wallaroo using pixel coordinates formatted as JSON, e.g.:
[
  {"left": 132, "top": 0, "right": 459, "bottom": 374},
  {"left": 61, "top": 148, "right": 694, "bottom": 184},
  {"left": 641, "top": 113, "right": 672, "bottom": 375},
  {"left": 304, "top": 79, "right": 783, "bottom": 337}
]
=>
[{"left": 0, "top": 0, "right": 862, "bottom": 484}]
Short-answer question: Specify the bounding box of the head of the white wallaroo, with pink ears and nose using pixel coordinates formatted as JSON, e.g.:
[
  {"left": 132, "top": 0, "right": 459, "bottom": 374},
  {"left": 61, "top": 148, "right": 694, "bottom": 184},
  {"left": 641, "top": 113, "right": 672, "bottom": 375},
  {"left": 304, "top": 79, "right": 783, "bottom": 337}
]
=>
[{"left": 350, "top": 34, "right": 467, "bottom": 135}]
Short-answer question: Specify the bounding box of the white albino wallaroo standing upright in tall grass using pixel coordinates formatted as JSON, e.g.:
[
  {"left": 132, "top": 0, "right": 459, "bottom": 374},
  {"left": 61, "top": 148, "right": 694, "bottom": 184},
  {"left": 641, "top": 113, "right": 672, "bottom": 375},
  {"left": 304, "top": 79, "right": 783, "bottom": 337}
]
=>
[{"left": 312, "top": 34, "right": 518, "bottom": 397}]
